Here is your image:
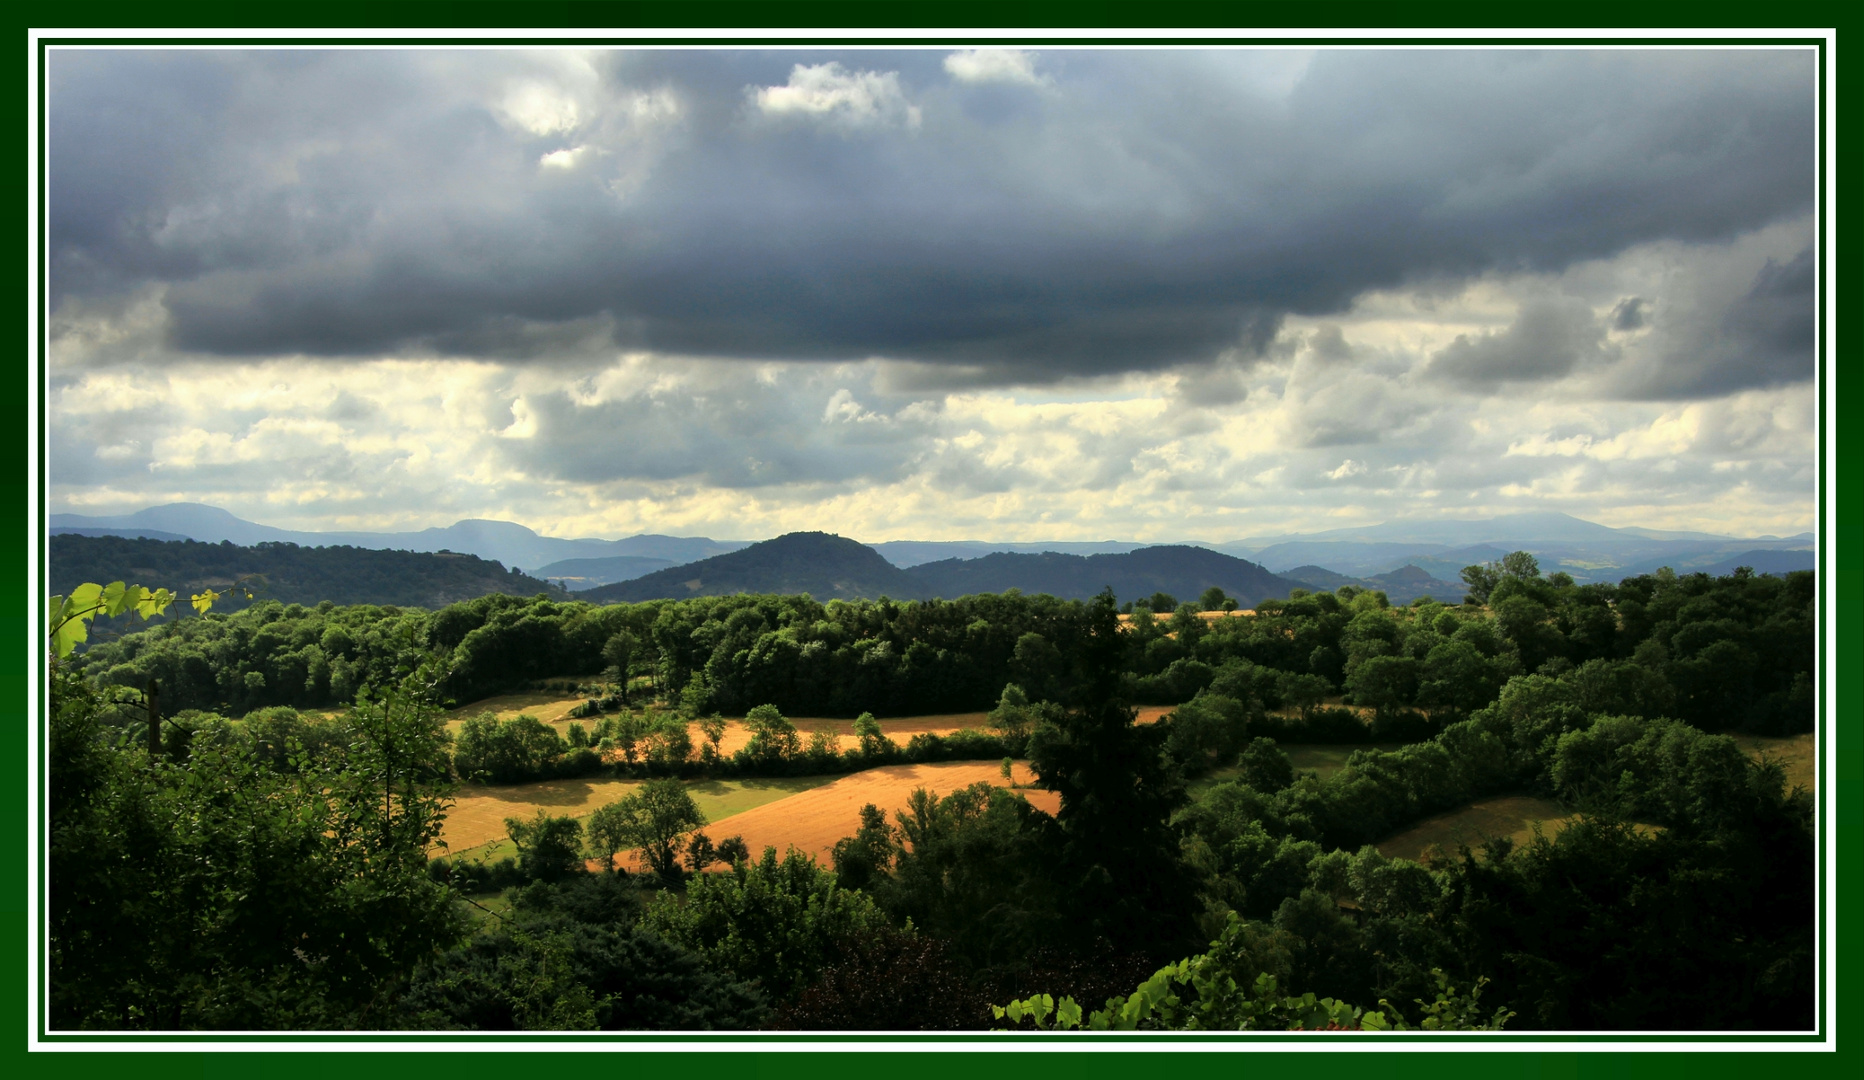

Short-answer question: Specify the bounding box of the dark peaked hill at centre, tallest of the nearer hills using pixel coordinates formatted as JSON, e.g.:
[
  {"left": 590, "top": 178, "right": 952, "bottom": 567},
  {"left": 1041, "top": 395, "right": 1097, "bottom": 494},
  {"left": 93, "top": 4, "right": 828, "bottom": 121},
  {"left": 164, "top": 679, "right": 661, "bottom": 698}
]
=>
[{"left": 576, "top": 532, "right": 930, "bottom": 604}]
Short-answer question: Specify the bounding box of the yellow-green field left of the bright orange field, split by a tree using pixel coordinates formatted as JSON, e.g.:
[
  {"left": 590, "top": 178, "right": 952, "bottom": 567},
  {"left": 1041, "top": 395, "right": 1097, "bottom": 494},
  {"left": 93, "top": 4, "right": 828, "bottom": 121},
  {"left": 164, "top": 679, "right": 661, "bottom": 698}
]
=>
[{"left": 444, "top": 776, "right": 831, "bottom": 862}]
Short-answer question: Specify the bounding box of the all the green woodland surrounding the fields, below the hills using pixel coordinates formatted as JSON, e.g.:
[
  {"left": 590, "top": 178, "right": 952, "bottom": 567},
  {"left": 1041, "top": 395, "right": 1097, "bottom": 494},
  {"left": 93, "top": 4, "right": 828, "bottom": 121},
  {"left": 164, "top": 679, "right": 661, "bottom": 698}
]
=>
[{"left": 50, "top": 561, "right": 1816, "bottom": 1030}]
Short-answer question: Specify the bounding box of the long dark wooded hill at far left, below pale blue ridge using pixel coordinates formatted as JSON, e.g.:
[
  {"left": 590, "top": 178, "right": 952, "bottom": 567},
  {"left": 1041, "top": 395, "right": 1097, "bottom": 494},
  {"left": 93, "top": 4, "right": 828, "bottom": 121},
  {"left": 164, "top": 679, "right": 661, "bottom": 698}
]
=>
[{"left": 50, "top": 533, "right": 567, "bottom": 610}]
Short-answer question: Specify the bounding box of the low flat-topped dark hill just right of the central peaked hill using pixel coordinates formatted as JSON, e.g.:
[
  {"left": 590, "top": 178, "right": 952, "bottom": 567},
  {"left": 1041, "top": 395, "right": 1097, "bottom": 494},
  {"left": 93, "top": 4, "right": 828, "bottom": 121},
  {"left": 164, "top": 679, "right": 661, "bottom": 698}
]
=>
[{"left": 906, "top": 545, "right": 1299, "bottom": 606}]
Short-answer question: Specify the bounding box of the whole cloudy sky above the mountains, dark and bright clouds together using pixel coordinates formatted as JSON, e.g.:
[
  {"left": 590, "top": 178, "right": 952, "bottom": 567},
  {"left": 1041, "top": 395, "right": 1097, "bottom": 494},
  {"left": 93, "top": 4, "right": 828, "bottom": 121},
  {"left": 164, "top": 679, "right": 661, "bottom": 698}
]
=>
[{"left": 45, "top": 48, "right": 1817, "bottom": 541}]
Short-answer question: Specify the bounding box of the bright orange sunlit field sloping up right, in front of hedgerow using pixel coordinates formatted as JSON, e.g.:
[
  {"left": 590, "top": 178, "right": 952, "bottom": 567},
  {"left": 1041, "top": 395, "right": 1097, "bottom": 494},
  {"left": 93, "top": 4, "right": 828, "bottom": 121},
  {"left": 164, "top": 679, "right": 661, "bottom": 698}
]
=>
[{"left": 615, "top": 761, "right": 1061, "bottom": 869}]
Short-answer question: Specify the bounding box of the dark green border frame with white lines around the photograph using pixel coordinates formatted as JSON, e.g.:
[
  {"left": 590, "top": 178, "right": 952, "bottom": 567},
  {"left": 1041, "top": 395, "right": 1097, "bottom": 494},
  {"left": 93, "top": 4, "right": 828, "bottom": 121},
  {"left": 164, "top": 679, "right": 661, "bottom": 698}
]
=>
[{"left": 0, "top": 0, "right": 1864, "bottom": 1080}]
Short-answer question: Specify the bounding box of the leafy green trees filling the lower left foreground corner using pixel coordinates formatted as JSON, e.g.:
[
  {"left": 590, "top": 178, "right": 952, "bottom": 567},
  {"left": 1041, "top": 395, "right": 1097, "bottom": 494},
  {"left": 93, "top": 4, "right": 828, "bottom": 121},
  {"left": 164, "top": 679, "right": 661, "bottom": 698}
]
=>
[{"left": 47, "top": 641, "right": 462, "bottom": 1030}]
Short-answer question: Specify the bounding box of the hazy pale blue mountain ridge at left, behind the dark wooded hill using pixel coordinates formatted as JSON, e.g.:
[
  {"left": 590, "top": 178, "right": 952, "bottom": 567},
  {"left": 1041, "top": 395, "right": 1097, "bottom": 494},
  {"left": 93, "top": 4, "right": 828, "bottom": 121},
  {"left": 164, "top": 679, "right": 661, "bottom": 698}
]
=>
[{"left": 48, "top": 502, "right": 749, "bottom": 567}]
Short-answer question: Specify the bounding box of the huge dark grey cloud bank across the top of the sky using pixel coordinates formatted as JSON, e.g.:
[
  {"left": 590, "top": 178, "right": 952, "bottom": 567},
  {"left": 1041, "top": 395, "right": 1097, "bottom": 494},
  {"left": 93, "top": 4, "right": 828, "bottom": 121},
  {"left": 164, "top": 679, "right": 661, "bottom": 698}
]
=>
[{"left": 48, "top": 50, "right": 1814, "bottom": 382}]
